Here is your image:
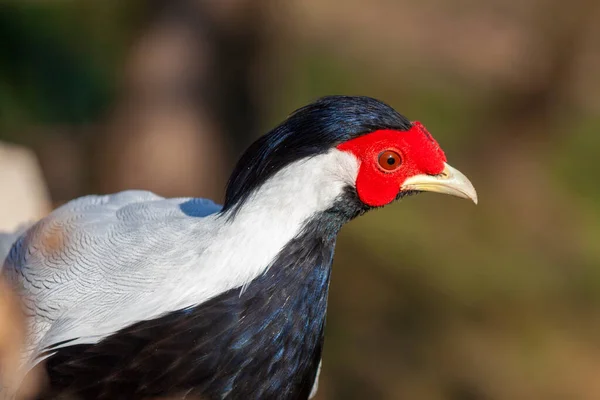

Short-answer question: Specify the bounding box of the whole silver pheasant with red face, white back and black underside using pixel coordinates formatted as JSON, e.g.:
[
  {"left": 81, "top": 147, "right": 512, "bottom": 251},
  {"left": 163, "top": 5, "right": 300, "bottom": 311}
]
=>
[{"left": 2, "top": 96, "right": 476, "bottom": 400}]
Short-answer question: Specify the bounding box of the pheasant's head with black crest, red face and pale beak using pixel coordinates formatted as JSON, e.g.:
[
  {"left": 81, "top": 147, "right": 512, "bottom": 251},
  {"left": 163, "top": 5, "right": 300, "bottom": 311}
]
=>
[{"left": 224, "top": 96, "right": 477, "bottom": 220}]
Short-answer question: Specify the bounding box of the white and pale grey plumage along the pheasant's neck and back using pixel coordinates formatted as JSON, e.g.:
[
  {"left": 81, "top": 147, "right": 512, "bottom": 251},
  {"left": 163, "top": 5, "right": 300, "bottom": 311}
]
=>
[{"left": 3, "top": 149, "right": 358, "bottom": 367}]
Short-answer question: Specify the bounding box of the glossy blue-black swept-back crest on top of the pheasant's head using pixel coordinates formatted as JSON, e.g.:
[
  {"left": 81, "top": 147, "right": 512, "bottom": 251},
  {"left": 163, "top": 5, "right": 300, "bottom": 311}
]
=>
[{"left": 223, "top": 96, "right": 412, "bottom": 213}]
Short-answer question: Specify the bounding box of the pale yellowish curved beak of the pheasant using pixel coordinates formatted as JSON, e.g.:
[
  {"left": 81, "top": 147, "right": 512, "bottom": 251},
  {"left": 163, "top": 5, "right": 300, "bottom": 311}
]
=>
[{"left": 401, "top": 163, "right": 477, "bottom": 204}]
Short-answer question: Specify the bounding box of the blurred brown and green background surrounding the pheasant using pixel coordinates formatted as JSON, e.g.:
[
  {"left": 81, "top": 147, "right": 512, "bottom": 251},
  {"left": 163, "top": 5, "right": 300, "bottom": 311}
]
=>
[{"left": 0, "top": 0, "right": 600, "bottom": 400}]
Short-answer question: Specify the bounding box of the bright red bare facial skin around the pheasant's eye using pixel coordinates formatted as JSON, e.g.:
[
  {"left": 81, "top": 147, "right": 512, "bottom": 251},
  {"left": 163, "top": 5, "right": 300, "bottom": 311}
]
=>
[{"left": 337, "top": 122, "right": 446, "bottom": 207}]
